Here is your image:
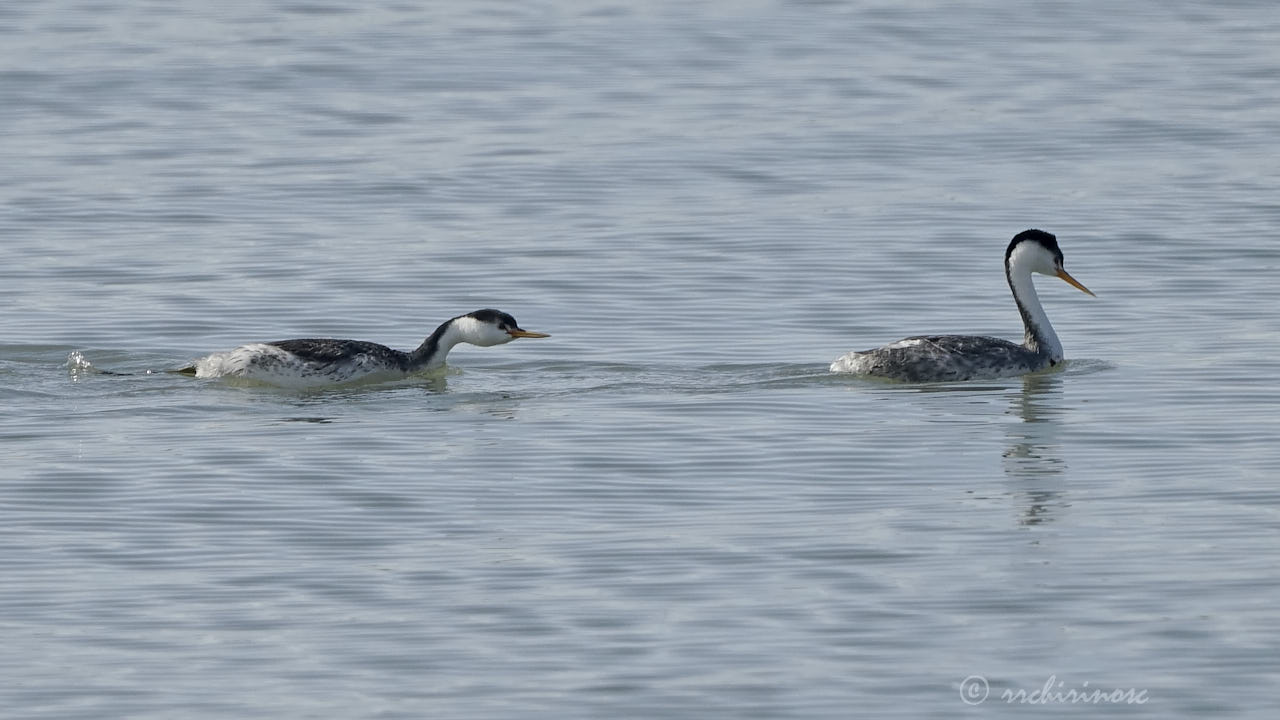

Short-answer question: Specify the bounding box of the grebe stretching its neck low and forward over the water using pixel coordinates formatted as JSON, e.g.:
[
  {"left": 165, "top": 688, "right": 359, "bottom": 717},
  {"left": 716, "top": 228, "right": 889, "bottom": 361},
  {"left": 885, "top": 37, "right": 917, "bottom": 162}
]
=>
[{"left": 178, "top": 310, "right": 550, "bottom": 388}]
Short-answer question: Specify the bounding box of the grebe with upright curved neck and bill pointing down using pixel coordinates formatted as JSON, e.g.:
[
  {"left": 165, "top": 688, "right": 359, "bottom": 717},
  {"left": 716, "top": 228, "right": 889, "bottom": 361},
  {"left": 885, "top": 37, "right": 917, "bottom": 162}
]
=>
[{"left": 831, "top": 229, "right": 1093, "bottom": 382}]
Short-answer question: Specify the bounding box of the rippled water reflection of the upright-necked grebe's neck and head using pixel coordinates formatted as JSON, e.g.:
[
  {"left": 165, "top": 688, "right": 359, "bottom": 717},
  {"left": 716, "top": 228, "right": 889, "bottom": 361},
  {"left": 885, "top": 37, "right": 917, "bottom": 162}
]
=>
[{"left": 1002, "top": 373, "right": 1068, "bottom": 525}]
